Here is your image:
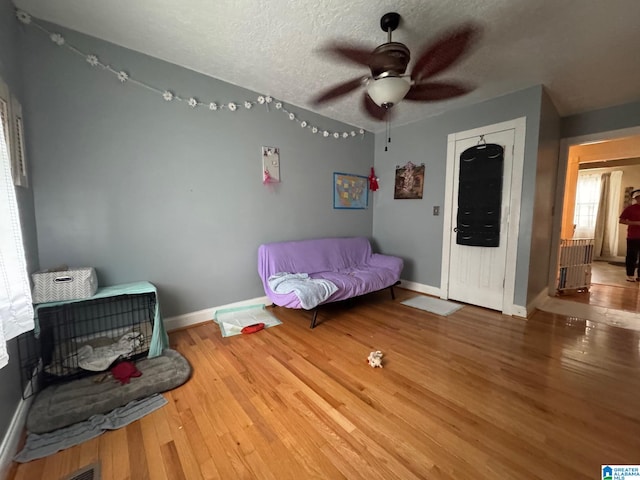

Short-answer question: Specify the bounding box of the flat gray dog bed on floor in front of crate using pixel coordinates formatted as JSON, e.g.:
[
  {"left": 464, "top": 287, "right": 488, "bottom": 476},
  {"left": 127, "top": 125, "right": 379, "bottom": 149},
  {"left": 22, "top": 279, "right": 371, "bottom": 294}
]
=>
[{"left": 27, "top": 349, "right": 191, "bottom": 433}]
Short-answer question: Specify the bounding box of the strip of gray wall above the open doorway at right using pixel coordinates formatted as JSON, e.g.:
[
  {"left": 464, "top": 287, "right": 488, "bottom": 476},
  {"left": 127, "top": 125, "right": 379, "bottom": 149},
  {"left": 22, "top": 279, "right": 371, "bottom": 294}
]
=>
[{"left": 561, "top": 100, "right": 640, "bottom": 138}]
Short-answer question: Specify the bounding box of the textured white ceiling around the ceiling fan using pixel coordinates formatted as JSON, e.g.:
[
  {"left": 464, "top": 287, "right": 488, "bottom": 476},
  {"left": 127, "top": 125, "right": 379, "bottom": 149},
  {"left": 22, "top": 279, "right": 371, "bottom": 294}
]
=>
[{"left": 15, "top": 0, "right": 640, "bottom": 131}]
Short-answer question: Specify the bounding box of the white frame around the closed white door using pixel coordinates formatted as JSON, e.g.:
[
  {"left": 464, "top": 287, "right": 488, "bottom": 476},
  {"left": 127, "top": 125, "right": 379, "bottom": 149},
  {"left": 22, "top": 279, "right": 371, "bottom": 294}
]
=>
[{"left": 440, "top": 117, "right": 527, "bottom": 316}]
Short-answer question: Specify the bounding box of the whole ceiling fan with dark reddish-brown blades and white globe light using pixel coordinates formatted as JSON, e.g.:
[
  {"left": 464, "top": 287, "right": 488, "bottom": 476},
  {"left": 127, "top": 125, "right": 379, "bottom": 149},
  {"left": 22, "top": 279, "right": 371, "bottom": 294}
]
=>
[{"left": 312, "top": 12, "right": 480, "bottom": 121}]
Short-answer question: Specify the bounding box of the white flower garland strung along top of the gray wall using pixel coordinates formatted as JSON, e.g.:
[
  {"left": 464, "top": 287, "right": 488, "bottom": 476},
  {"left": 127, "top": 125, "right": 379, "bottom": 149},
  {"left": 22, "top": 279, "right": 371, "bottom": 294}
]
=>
[{"left": 16, "top": 10, "right": 365, "bottom": 139}]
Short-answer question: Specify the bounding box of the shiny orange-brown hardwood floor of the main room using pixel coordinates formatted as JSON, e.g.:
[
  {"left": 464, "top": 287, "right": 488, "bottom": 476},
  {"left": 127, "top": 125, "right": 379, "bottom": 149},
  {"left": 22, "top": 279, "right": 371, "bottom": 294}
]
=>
[{"left": 14, "top": 289, "right": 640, "bottom": 480}]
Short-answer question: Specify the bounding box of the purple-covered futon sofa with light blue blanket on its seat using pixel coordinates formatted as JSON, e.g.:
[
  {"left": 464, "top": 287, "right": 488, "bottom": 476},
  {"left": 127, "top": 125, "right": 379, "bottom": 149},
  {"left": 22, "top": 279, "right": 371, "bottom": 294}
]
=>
[{"left": 258, "top": 237, "right": 403, "bottom": 328}]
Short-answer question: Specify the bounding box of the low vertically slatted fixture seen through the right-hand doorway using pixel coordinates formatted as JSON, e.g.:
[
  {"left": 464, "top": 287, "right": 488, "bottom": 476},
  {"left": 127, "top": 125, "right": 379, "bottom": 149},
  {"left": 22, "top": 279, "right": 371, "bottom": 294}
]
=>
[{"left": 558, "top": 238, "right": 594, "bottom": 292}]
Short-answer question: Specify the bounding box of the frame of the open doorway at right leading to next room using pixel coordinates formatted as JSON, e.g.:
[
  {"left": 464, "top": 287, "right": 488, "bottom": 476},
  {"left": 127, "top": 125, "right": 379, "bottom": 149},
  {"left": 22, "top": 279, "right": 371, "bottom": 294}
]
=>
[{"left": 547, "top": 127, "right": 640, "bottom": 297}]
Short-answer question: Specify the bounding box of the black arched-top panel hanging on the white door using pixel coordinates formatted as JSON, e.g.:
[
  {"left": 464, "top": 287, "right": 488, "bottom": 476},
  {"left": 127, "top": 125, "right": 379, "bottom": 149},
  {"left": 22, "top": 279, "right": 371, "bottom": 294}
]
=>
[{"left": 456, "top": 143, "right": 504, "bottom": 247}]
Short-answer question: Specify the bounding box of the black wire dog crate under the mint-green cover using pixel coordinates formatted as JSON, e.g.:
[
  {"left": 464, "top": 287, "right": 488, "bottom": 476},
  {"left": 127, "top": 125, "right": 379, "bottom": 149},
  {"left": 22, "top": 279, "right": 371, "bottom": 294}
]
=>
[{"left": 18, "top": 293, "right": 156, "bottom": 399}]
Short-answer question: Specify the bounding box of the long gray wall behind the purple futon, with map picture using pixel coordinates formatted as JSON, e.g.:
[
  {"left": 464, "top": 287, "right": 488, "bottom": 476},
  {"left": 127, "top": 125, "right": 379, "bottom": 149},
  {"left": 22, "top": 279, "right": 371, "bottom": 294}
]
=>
[{"left": 21, "top": 21, "right": 374, "bottom": 317}]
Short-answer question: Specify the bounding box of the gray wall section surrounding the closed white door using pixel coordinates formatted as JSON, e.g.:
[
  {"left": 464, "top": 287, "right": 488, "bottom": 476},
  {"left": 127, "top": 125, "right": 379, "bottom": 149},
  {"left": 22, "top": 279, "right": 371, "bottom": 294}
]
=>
[{"left": 373, "top": 86, "right": 542, "bottom": 305}]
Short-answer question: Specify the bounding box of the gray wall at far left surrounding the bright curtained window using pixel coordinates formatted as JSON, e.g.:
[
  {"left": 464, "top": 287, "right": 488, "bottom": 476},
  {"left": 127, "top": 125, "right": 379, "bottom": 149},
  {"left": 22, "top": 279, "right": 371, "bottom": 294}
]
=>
[{"left": 0, "top": 0, "right": 38, "bottom": 452}]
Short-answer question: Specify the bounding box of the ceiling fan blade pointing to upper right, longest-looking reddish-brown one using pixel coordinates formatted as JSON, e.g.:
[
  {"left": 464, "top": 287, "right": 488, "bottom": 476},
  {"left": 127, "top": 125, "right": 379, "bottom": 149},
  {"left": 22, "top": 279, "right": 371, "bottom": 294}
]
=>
[{"left": 411, "top": 24, "right": 480, "bottom": 82}]
